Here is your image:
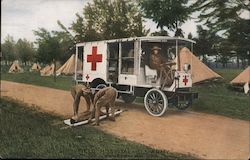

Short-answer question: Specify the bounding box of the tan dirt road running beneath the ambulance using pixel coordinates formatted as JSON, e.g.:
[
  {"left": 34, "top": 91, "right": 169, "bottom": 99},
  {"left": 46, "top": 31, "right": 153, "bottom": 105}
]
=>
[{"left": 1, "top": 81, "right": 250, "bottom": 159}]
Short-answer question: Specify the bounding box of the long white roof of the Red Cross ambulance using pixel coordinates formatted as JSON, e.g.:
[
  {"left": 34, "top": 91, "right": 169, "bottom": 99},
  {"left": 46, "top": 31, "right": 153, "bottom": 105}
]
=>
[{"left": 76, "top": 36, "right": 196, "bottom": 46}]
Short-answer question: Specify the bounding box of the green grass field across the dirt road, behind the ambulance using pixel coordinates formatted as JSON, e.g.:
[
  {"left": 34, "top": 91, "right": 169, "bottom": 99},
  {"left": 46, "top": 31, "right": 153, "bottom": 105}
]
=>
[{"left": 2, "top": 69, "right": 250, "bottom": 120}]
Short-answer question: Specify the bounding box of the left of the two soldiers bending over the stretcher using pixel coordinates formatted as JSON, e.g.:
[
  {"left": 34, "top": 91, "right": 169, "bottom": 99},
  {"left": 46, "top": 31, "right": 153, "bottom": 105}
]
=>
[{"left": 70, "top": 84, "right": 93, "bottom": 123}]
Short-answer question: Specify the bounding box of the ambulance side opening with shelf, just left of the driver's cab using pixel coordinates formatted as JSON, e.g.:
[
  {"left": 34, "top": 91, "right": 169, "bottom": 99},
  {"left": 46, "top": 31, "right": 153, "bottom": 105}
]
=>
[{"left": 121, "top": 42, "right": 134, "bottom": 74}]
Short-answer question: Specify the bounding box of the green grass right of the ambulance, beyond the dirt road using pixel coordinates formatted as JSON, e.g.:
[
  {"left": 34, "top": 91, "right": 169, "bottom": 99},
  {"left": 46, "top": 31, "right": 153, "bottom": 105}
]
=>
[{"left": 191, "top": 69, "right": 250, "bottom": 120}]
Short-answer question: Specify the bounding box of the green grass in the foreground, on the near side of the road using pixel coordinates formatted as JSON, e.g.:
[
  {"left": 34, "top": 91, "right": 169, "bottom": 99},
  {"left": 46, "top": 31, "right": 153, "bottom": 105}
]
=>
[{"left": 0, "top": 97, "right": 194, "bottom": 159}]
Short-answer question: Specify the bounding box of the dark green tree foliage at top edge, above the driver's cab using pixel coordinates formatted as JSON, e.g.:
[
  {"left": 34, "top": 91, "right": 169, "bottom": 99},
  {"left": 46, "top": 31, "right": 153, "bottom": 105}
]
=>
[{"left": 140, "top": 0, "right": 191, "bottom": 36}]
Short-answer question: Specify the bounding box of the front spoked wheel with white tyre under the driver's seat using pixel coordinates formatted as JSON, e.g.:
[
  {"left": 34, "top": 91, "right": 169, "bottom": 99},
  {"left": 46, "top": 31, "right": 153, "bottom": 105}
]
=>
[{"left": 144, "top": 88, "right": 168, "bottom": 117}]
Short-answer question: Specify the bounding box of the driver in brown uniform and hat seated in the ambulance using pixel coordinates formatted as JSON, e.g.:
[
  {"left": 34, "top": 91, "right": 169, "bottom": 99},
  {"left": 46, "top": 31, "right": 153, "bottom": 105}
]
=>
[{"left": 149, "top": 46, "right": 175, "bottom": 87}]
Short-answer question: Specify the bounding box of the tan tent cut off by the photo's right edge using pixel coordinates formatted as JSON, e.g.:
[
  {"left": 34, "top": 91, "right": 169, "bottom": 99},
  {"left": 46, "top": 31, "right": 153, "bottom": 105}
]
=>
[{"left": 230, "top": 66, "right": 250, "bottom": 85}]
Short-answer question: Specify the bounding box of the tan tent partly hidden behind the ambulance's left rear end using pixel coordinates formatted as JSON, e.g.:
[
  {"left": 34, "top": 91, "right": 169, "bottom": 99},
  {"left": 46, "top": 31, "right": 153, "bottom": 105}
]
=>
[{"left": 56, "top": 54, "right": 82, "bottom": 75}]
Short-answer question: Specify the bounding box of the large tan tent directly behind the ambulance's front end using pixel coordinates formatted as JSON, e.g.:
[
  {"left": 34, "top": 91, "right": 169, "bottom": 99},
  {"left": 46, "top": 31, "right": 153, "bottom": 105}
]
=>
[{"left": 175, "top": 47, "right": 222, "bottom": 83}]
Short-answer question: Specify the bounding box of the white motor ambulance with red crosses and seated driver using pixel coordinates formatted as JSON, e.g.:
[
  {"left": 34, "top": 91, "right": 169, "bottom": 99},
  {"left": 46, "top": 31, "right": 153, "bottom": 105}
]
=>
[{"left": 75, "top": 36, "right": 198, "bottom": 116}]
